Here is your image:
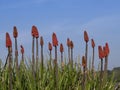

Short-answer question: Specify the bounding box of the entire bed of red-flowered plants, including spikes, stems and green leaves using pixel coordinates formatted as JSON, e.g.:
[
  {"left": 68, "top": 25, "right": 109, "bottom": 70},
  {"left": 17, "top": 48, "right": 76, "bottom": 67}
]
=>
[{"left": 0, "top": 26, "right": 116, "bottom": 90}]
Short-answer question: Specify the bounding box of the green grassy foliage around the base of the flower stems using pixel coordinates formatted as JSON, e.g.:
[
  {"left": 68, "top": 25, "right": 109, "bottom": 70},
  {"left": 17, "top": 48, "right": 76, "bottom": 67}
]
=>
[{"left": 0, "top": 61, "right": 115, "bottom": 90}]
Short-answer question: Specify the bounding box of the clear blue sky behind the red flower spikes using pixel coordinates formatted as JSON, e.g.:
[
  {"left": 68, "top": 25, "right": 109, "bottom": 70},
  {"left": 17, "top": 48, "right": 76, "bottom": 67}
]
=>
[{"left": 0, "top": 0, "right": 120, "bottom": 69}]
